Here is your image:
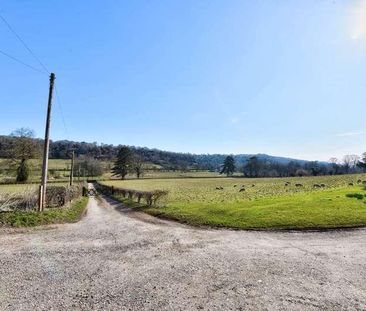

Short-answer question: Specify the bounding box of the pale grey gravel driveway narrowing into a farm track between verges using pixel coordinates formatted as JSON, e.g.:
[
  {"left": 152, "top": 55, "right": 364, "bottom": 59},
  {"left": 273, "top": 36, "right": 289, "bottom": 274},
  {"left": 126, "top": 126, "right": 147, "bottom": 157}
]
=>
[{"left": 0, "top": 198, "right": 366, "bottom": 311}]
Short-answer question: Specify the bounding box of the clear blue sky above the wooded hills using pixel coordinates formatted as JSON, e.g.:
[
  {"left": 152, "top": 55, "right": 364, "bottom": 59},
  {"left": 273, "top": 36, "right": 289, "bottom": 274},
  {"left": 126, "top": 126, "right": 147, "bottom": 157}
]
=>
[{"left": 0, "top": 0, "right": 366, "bottom": 160}]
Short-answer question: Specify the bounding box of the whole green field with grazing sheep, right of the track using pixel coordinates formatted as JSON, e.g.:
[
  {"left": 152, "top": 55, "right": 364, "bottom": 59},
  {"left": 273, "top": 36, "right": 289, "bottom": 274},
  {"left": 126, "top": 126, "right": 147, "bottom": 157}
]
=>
[{"left": 103, "top": 174, "right": 366, "bottom": 229}]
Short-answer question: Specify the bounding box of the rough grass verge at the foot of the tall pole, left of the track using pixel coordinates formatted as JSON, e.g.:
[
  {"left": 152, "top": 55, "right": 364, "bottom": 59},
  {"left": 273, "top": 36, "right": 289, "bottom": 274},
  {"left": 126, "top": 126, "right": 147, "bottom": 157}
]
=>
[{"left": 0, "top": 197, "right": 88, "bottom": 227}]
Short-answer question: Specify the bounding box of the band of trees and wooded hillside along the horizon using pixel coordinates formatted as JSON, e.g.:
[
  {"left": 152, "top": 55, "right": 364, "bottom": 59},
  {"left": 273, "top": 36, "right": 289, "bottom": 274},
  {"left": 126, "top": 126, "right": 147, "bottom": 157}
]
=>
[{"left": 0, "top": 128, "right": 366, "bottom": 182}]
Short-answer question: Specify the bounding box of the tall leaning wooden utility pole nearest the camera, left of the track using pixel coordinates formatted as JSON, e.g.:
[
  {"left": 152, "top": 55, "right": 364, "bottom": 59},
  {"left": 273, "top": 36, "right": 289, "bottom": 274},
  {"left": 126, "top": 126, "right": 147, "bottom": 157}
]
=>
[{"left": 39, "top": 73, "right": 56, "bottom": 211}]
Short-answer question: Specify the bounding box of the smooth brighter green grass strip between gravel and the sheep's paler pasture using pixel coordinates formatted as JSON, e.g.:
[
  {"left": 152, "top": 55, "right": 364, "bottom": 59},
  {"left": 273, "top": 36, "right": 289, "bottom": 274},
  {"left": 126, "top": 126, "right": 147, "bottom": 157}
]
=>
[{"left": 114, "top": 188, "right": 366, "bottom": 230}]
